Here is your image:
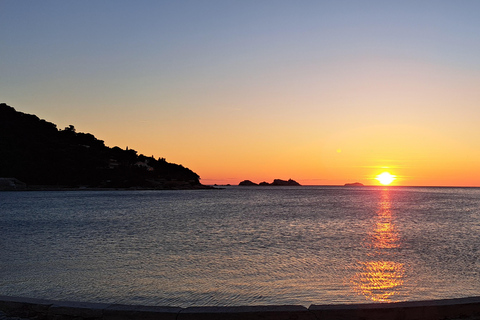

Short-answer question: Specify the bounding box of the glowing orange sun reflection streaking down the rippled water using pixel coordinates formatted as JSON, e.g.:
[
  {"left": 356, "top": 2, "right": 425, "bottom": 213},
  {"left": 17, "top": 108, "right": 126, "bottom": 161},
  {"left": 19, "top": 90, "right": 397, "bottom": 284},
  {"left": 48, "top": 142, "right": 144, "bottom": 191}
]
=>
[{"left": 350, "top": 189, "right": 405, "bottom": 302}]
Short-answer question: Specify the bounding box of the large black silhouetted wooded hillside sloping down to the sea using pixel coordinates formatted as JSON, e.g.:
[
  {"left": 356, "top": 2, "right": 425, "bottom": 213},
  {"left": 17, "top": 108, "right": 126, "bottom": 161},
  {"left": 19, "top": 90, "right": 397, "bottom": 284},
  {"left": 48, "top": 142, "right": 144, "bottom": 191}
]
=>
[{"left": 0, "top": 103, "right": 209, "bottom": 189}]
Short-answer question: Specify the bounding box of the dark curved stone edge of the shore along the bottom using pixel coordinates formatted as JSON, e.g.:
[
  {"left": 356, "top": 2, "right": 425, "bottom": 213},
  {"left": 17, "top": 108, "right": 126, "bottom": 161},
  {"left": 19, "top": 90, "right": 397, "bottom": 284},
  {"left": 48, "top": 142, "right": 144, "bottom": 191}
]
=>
[{"left": 0, "top": 296, "right": 480, "bottom": 320}]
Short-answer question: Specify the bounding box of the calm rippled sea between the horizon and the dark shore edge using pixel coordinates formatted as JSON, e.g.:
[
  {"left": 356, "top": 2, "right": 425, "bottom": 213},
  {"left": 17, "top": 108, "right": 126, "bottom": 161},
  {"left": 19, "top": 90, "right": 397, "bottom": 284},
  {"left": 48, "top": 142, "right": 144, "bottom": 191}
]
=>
[{"left": 0, "top": 187, "right": 480, "bottom": 307}]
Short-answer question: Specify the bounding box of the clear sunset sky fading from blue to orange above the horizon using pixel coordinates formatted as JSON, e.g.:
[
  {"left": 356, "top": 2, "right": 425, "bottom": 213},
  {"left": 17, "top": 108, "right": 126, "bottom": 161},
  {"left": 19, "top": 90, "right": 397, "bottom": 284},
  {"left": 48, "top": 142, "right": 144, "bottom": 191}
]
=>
[{"left": 0, "top": 0, "right": 480, "bottom": 186}]
